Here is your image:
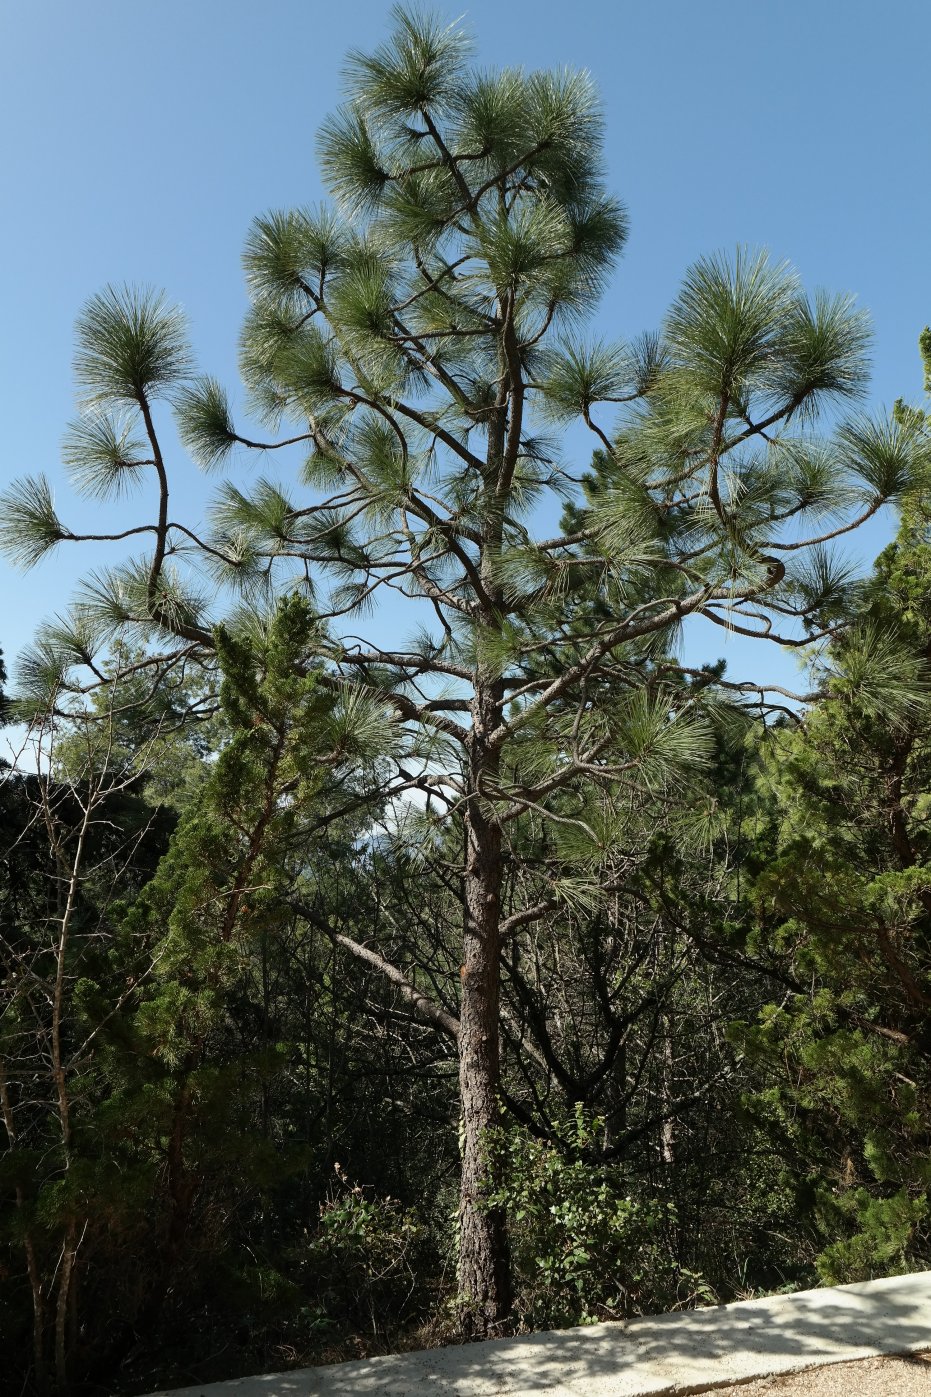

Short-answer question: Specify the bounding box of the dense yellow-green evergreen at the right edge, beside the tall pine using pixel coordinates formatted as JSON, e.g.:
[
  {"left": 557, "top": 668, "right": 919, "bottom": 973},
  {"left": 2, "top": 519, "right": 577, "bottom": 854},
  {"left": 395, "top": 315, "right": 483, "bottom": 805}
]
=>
[{"left": 738, "top": 330, "right": 931, "bottom": 1282}]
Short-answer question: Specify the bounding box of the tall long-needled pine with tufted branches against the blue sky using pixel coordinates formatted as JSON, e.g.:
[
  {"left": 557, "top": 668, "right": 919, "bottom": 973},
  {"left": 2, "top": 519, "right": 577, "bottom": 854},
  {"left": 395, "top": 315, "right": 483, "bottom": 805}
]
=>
[{"left": 4, "top": 10, "right": 927, "bottom": 1333}]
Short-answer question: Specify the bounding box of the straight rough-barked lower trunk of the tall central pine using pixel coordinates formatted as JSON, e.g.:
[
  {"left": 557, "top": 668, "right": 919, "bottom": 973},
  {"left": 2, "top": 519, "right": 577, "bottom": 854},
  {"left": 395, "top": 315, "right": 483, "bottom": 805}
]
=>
[{"left": 459, "top": 704, "right": 510, "bottom": 1338}]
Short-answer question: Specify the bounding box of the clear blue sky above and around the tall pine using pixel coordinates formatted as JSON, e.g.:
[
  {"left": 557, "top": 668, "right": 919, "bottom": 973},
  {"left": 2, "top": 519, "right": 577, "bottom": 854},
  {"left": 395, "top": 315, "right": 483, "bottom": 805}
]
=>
[{"left": 0, "top": 0, "right": 931, "bottom": 698}]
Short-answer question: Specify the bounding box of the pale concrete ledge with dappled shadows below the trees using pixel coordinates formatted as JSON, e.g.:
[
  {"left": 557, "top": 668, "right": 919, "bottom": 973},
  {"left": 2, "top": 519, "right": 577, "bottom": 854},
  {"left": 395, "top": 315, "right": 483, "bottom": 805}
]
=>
[{"left": 143, "top": 1271, "right": 931, "bottom": 1397}]
